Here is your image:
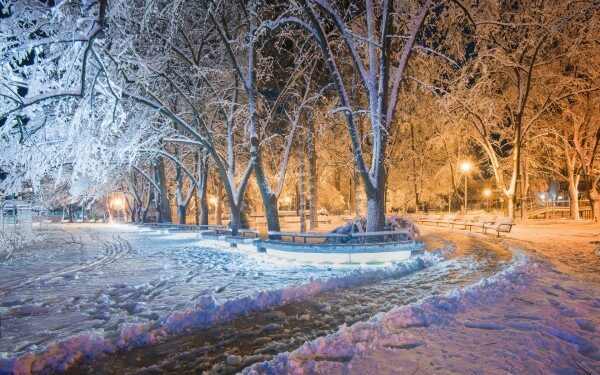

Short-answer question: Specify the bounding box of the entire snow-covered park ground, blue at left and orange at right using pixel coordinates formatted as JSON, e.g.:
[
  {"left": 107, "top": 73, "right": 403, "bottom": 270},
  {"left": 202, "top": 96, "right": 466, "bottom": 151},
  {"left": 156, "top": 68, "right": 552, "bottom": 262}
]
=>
[{"left": 0, "top": 221, "right": 600, "bottom": 374}]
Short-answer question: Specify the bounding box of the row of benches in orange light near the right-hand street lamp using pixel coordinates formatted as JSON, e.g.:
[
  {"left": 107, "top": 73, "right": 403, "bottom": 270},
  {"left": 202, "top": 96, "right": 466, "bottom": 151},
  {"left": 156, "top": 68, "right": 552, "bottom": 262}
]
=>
[{"left": 416, "top": 214, "right": 516, "bottom": 237}]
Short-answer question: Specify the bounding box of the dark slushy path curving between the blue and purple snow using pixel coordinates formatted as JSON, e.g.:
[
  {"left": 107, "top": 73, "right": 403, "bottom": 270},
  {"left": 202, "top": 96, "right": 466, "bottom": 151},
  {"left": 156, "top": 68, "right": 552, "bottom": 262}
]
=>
[{"left": 62, "top": 233, "right": 510, "bottom": 374}]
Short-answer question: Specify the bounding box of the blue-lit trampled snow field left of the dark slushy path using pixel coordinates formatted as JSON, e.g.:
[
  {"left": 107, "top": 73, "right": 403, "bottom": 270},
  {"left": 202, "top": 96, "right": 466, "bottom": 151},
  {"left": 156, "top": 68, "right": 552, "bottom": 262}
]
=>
[{"left": 0, "top": 224, "right": 448, "bottom": 372}]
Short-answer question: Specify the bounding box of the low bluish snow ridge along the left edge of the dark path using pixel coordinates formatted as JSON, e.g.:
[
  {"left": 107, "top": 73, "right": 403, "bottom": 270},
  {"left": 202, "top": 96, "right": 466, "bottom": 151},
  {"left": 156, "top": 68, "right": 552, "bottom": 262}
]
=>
[{"left": 0, "top": 253, "right": 443, "bottom": 374}]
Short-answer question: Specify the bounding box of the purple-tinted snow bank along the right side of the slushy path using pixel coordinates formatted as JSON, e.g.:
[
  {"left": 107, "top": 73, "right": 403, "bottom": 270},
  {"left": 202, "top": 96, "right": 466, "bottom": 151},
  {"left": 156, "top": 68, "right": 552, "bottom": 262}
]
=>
[{"left": 243, "top": 255, "right": 600, "bottom": 375}]
